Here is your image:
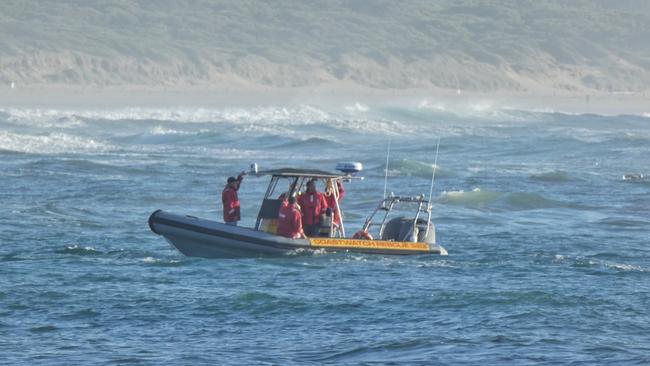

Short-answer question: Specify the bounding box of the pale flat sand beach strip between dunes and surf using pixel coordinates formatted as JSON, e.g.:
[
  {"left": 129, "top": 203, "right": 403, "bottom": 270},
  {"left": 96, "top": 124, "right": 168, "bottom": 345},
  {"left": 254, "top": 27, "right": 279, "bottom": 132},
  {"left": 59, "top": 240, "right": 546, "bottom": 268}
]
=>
[{"left": 0, "top": 83, "right": 650, "bottom": 116}]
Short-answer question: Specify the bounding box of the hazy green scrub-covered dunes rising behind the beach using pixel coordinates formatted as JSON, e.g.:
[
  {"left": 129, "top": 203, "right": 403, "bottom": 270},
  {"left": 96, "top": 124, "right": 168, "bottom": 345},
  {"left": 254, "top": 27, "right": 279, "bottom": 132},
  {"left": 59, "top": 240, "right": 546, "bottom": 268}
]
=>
[{"left": 0, "top": 0, "right": 650, "bottom": 93}]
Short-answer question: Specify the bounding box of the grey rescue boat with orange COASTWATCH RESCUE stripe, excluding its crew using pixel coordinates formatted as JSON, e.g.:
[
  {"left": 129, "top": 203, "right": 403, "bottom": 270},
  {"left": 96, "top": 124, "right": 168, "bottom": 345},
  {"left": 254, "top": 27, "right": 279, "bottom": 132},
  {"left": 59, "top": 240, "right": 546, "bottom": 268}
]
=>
[{"left": 149, "top": 167, "right": 447, "bottom": 258}]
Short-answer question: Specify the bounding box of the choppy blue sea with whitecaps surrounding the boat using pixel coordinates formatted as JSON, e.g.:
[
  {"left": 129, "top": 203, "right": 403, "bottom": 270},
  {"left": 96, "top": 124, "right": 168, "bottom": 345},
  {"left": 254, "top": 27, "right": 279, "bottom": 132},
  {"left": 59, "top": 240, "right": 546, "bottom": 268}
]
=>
[{"left": 0, "top": 102, "right": 650, "bottom": 365}]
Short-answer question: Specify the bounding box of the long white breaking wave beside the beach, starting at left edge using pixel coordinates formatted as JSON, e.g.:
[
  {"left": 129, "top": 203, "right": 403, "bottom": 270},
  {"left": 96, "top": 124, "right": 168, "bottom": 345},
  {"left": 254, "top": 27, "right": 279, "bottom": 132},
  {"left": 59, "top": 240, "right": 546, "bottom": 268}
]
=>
[{"left": 0, "top": 105, "right": 413, "bottom": 137}]
